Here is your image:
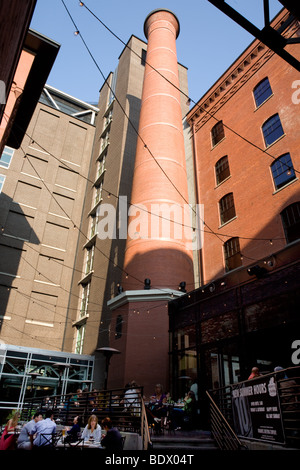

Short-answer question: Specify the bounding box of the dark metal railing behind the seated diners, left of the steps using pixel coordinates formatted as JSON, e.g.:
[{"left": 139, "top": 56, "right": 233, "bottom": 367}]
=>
[{"left": 21, "top": 387, "right": 150, "bottom": 450}]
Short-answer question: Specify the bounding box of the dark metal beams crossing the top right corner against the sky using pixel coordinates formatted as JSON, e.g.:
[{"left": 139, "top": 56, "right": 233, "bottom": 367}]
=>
[{"left": 208, "top": 0, "right": 300, "bottom": 72}]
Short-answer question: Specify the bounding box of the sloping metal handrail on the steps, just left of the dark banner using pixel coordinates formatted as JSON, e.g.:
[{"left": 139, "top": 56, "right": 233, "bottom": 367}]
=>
[{"left": 206, "top": 392, "right": 247, "bottom": 450}]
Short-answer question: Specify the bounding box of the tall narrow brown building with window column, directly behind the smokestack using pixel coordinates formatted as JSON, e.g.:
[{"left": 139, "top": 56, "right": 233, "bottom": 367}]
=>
[{"left": 65, "top": 31, "right": 187, "bottom": 394}]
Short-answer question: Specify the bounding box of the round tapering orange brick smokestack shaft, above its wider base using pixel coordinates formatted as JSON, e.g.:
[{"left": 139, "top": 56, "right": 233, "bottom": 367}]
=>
[{"left": 122, "top": 9, "right": 193, "bottom": 290}]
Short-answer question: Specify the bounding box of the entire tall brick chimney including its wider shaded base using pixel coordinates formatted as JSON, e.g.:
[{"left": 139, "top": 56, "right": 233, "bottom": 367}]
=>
[{"left": 108, "top": 9, "right": 194, "bottom": 395}]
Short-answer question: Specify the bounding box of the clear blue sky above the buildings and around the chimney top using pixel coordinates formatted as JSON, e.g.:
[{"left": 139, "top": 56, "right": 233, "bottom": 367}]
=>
[{"left": 31, "top": 0, "right": 282, "bottom": 103}]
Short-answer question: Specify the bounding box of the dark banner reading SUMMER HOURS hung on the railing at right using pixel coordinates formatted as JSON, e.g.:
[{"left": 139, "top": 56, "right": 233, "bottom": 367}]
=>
[{"left": 231, "top": 376, "right": 284, "bottom": 444}]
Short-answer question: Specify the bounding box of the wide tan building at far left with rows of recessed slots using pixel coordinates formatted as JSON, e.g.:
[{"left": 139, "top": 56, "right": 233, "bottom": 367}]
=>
[{"left": 0, "top": 86, "right": 97, "bottom": 351}]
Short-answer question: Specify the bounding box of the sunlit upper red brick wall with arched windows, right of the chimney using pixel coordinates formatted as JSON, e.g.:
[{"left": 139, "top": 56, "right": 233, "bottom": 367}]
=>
[{"left": 187, "top": 10, "right": 300, "bottom": 284}]
